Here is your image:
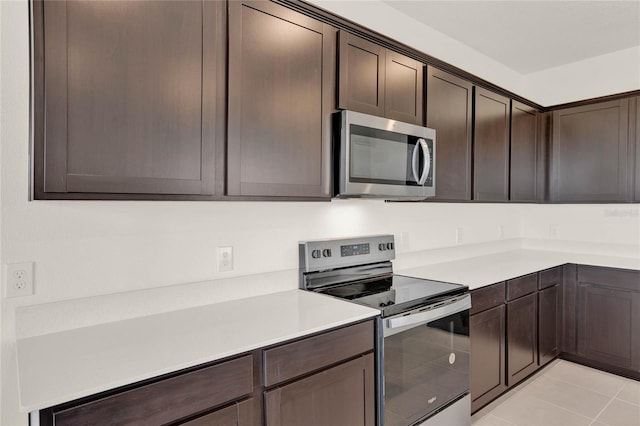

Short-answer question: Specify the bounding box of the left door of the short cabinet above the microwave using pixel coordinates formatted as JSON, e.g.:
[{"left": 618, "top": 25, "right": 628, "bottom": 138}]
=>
[{"left": 338, "top": 31, "right": 386, "bottom": 117}]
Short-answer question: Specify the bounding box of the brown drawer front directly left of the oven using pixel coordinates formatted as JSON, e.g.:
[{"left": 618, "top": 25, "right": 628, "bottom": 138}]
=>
[{"left": 264, "top": 321, "right": 374, "bottom": 387}]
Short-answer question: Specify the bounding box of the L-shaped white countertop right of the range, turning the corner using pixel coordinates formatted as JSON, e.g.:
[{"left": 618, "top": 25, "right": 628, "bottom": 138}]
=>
[{"left": 395, "top": 249, "right": 640, "bottom": 290}]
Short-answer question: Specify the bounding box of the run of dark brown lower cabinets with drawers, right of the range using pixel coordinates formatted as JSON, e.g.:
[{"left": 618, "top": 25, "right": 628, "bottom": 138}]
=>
[{"left": 470, "top": 266, "right": 563, "bottom": 412}]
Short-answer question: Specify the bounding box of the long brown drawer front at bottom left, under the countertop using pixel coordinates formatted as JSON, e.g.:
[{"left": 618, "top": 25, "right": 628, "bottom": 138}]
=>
[{"left": 53, "top": 355, "right": 253, "bottom": 425}]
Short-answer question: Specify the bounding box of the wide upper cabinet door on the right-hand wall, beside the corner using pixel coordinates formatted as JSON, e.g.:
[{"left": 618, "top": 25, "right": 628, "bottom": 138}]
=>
[{"left": 551, "top": 99, "right": 629, "bottom": 202}]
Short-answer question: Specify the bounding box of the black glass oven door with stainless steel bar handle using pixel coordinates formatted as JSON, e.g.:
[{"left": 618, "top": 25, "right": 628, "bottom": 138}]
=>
[{"left": 382, "top": 294, "right": 471, "bottom": 426}]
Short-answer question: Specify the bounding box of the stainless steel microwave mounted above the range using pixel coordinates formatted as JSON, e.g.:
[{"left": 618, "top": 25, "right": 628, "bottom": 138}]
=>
[{"left": 333, "top": 111, "right": 436, "bottom": 200}]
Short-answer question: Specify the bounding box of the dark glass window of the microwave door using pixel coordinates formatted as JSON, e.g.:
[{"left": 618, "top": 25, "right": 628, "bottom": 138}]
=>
[{"left": 349, "top": 124, "right": 430, "bottom": 186}]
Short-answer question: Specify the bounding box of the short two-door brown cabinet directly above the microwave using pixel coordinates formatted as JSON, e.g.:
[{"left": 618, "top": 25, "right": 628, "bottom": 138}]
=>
[{"left": 338, "top": 31, "right": 424, "bottom": 125}]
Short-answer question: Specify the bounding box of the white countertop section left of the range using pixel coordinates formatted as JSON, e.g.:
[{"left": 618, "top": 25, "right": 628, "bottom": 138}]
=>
[{"left": 16, "top": 290, "right": 379, "bottom": 411}]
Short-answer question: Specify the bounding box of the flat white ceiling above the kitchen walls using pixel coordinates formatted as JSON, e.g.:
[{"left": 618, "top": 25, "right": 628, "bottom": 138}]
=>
[{"left": 383, "top": 0, "right": 640, "bottom": 75}]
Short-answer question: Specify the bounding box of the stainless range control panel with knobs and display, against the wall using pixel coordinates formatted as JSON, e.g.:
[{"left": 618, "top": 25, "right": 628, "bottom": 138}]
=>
[{"left": 299, "top": 235, "right": 396, "bottom": 272}]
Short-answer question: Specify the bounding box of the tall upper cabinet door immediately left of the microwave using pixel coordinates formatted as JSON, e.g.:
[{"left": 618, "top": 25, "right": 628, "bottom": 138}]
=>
[{"left": 227, "top": 1, "right": 335, "bottom": 197}]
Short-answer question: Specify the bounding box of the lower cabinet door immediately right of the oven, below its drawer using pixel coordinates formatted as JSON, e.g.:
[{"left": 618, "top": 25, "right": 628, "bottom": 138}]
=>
[{"left": 469, "top": 305, "right": 507, "bottom": 412}]
